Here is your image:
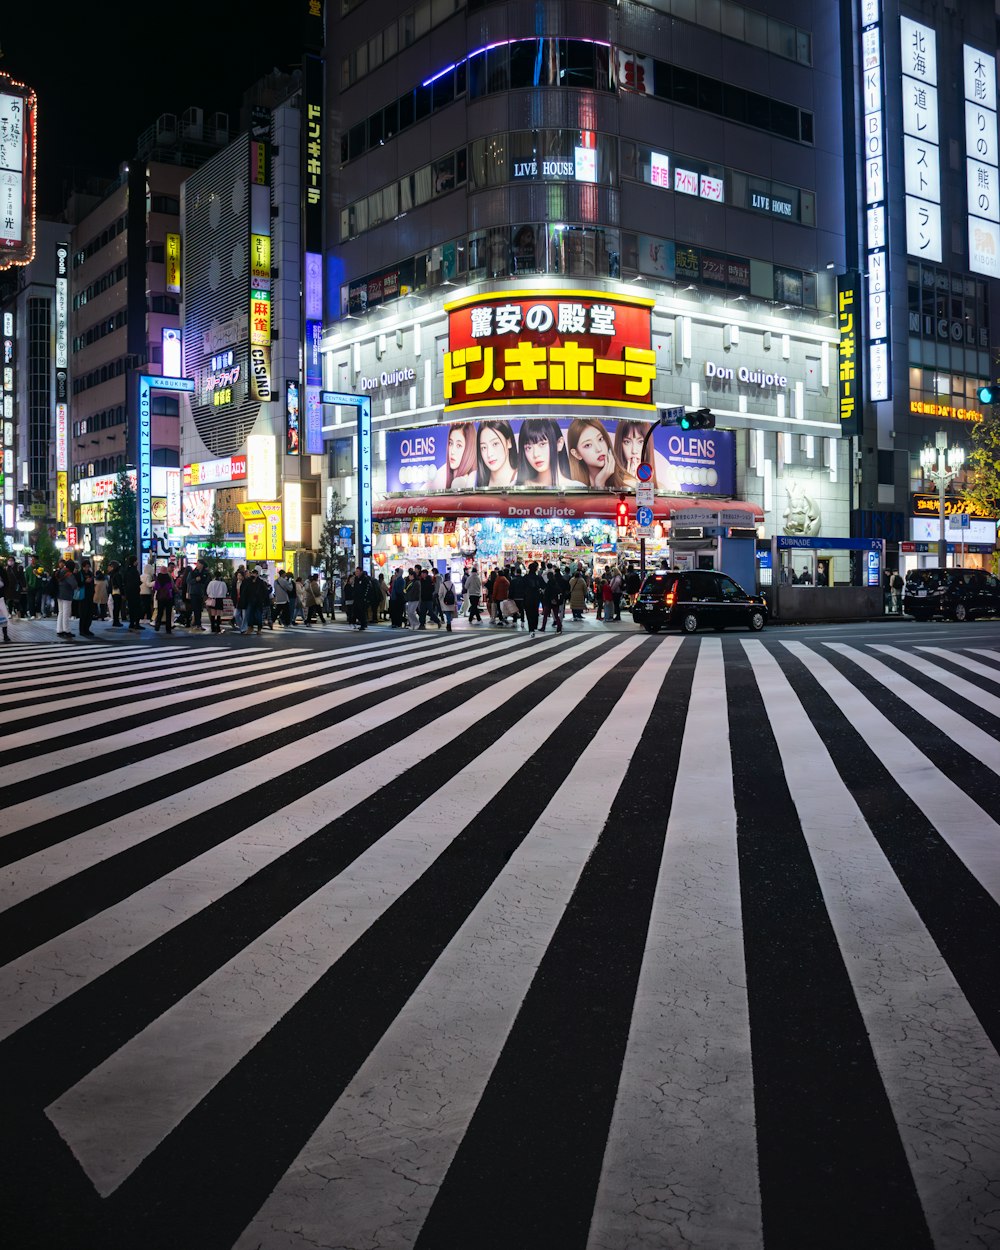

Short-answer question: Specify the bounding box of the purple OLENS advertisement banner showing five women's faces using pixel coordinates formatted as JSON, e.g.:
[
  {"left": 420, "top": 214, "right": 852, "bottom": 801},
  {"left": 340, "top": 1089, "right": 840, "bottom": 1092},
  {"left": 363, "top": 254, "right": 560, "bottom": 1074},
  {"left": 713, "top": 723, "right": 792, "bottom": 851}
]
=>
[{"left": 385, "top": 418, "right": 736, "bottom": 495}]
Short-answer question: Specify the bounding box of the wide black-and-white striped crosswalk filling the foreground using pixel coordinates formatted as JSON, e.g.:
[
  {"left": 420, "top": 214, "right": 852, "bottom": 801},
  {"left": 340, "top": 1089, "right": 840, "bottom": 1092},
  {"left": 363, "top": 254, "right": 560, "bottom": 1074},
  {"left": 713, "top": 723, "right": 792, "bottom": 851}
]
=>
[{"left": 0, "top": 631, "right": 1000, "bottom": 1250}]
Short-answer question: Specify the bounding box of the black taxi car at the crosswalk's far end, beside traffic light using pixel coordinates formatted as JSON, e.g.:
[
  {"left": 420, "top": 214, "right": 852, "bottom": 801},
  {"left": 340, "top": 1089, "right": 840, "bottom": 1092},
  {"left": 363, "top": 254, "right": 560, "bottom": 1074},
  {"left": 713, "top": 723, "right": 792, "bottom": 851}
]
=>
[{"left": 633, "top": 569, "right": 768, "bottom": 634}]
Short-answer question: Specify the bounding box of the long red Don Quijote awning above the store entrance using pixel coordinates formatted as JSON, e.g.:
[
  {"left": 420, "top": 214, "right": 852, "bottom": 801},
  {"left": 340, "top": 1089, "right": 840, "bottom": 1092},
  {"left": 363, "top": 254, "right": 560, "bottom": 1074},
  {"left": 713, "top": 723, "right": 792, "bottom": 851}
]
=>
[{"left": 371, "top": 491, "right": 764, "bottom": 525}]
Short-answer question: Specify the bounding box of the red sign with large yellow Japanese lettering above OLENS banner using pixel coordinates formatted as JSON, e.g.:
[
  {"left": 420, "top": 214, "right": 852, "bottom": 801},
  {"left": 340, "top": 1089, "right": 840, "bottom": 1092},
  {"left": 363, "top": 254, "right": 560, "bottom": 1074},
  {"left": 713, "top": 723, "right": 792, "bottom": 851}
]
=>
[{"left": 444, "top": 291, "right": 656, "bottom": 411}]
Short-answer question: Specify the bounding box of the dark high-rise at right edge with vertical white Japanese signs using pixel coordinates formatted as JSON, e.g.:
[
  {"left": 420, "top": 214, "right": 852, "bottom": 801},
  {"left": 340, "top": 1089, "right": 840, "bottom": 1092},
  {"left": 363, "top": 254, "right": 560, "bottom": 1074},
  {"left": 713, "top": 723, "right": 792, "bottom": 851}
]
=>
[{"left": 843, "top": 0, "right": 1000, "bottom": 569}]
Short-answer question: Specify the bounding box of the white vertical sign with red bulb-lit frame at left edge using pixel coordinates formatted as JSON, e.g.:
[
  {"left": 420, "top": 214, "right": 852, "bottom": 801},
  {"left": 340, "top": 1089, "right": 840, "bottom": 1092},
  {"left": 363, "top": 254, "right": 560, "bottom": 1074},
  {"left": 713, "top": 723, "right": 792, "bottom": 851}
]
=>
[{"left": 0, "top": 74, "right": 36, "bottom": 269}]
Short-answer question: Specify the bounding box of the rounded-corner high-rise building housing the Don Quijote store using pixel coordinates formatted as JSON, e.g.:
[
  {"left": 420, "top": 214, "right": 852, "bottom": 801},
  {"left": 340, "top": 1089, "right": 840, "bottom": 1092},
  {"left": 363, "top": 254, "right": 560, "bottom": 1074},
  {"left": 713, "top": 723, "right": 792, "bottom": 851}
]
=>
[{"left": 321, "top": 0, "right": 853, "bottom": 581}]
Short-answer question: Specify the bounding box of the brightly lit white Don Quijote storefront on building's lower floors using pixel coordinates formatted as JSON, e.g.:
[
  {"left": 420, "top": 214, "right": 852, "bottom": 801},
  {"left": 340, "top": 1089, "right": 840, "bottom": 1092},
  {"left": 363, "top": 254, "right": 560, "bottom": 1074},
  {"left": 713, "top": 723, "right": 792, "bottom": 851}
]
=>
[{"left": 321, "top": 280, "right": 850, "bottom": 583}]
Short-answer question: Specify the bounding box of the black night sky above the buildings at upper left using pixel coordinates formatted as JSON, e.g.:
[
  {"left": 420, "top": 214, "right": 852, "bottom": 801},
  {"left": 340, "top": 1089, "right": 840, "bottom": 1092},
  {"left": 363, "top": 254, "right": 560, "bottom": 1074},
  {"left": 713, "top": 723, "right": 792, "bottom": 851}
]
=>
[{"left": 0, "top": 0, "right": 301, "bottom": 215}]
